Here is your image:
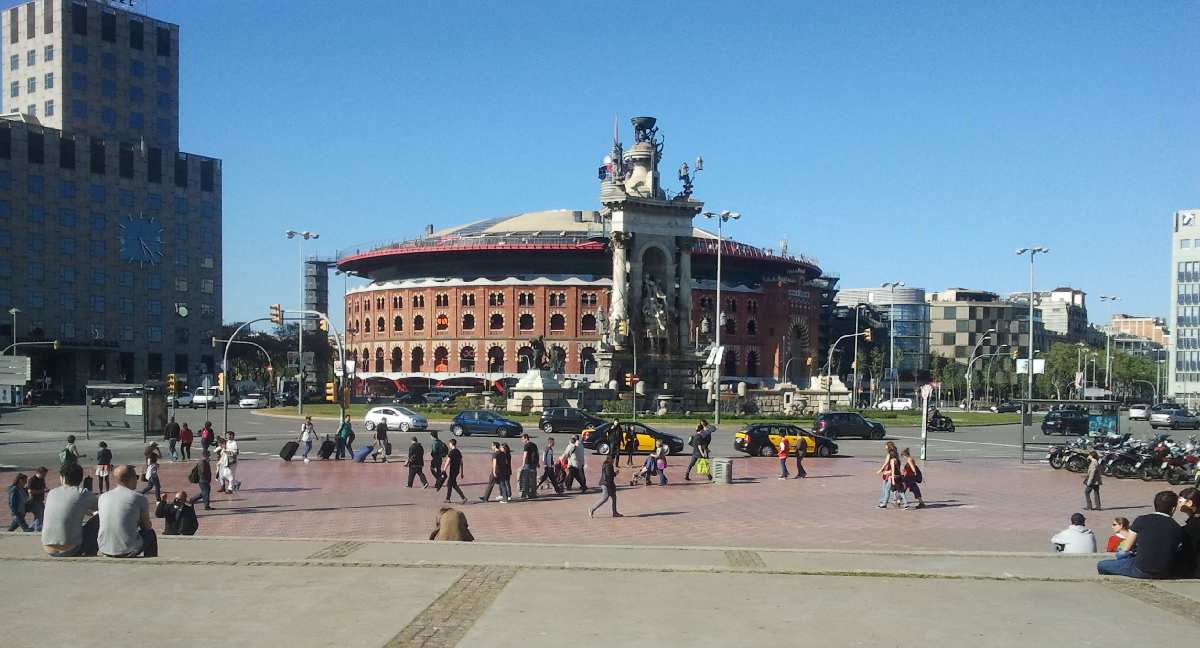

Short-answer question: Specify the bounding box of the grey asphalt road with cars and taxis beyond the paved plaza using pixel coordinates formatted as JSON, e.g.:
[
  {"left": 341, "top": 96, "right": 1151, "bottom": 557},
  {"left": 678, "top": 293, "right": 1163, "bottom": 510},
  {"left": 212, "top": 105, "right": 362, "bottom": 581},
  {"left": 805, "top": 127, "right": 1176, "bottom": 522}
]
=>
[{"left": 0, "top": 406, "right": 1180, "bottom": 470}]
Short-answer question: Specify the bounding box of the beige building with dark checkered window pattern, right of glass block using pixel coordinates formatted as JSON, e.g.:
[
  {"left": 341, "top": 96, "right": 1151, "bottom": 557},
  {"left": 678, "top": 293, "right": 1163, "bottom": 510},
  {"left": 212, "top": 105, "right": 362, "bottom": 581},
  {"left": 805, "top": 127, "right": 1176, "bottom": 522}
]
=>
[{"left": 925, "top": 288, "right": 1049, "bottom": 364}]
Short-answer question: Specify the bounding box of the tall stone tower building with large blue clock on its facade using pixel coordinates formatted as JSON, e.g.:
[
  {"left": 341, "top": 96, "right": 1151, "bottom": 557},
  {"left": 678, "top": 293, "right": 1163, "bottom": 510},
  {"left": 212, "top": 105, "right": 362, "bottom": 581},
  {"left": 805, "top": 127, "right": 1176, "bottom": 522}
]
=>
[{"left": 0, "top": 0, "right": 222, "bottom": 401}]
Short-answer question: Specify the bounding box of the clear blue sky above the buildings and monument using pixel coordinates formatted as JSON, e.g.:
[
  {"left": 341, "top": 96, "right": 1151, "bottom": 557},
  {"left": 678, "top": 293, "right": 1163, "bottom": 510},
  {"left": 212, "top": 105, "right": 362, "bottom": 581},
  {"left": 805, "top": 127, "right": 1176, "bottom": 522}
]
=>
[{"left": 142, "top": 0, "right": 1200, "bottom": 322}]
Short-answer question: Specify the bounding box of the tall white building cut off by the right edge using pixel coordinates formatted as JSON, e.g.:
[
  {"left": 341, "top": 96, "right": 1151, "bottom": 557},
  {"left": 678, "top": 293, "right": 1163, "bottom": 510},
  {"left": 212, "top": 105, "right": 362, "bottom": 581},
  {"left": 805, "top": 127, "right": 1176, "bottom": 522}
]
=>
[{"left": 1168, "top": 209, "right": 1200, "bottom": 401}]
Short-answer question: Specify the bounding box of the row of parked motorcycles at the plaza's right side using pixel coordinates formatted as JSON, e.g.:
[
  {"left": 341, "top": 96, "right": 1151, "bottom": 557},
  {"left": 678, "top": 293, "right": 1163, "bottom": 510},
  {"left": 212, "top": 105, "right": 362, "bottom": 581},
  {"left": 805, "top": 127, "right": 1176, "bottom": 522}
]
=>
[{"left": 1046, "top": 433, "right": 1200, "bottom": 487}]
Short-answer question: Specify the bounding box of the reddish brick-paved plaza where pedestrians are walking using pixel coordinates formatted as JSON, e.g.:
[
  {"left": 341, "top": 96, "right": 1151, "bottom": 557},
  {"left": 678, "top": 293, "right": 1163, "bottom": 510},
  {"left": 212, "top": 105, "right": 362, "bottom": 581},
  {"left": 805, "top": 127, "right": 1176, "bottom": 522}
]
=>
[{"left": 142, "top": 455, "right": 1168, "bottom": 551}]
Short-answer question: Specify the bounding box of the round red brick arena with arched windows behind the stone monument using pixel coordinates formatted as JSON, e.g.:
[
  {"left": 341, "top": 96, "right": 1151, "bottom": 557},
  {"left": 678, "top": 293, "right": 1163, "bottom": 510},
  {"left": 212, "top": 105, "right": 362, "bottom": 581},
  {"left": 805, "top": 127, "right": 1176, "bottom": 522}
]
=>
[{"left": 337, "top": 210, "right": 821, "bottom": 389}]
